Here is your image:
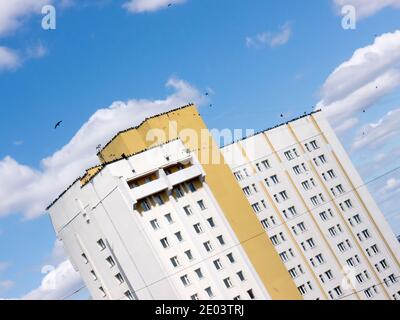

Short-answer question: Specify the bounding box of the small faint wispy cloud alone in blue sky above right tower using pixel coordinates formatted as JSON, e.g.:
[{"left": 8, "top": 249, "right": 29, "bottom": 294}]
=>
[{"left": 246, "top": 22, "right": 292, "bottom": 48}]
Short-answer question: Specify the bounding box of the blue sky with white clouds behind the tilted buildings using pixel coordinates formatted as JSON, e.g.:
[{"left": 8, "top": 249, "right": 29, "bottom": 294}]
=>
[{"left": 0, "top": 0, "right": 400, "bottom": 298}]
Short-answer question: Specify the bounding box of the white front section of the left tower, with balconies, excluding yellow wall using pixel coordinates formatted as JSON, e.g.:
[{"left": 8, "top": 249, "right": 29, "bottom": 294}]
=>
[{"left": 49, "top": 140, "right": 270, "bottom": 300}]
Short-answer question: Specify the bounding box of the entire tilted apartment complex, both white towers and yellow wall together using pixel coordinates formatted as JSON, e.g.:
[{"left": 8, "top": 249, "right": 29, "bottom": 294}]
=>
[{"left": 48, "top": 105, "right": 400, "bottom": 300}]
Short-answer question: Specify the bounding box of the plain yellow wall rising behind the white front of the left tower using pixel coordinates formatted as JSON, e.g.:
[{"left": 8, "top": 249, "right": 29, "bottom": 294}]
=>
[{"left": 99, "top": 105, "right": 302, "bottom": 300}]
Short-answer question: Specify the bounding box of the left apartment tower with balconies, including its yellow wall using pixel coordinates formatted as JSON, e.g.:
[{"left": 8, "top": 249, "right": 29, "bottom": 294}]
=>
[{"left": 48, "top": 105, "right": 302, "bottom": 300}]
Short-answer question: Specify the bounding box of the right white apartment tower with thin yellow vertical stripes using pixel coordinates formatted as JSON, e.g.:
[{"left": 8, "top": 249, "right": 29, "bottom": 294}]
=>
[{"left": 222, "top": 112, "right": 400, "bottom": 299}]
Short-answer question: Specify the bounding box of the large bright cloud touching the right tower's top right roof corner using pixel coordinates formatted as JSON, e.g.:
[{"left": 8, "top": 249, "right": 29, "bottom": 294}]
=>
[{"left": 317, "top": 30, "right": 400, "bottom": 130}]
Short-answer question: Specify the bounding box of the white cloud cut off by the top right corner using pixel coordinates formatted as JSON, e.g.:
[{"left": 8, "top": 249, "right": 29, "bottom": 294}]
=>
[{"left": 333, "top": 0, "right": 400, "bottom": 19}]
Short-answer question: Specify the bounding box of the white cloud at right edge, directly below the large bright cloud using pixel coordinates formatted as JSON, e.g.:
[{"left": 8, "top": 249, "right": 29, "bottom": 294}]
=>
[{"left": 352, "top": 109, "right": 400, "bottom": 150}]
